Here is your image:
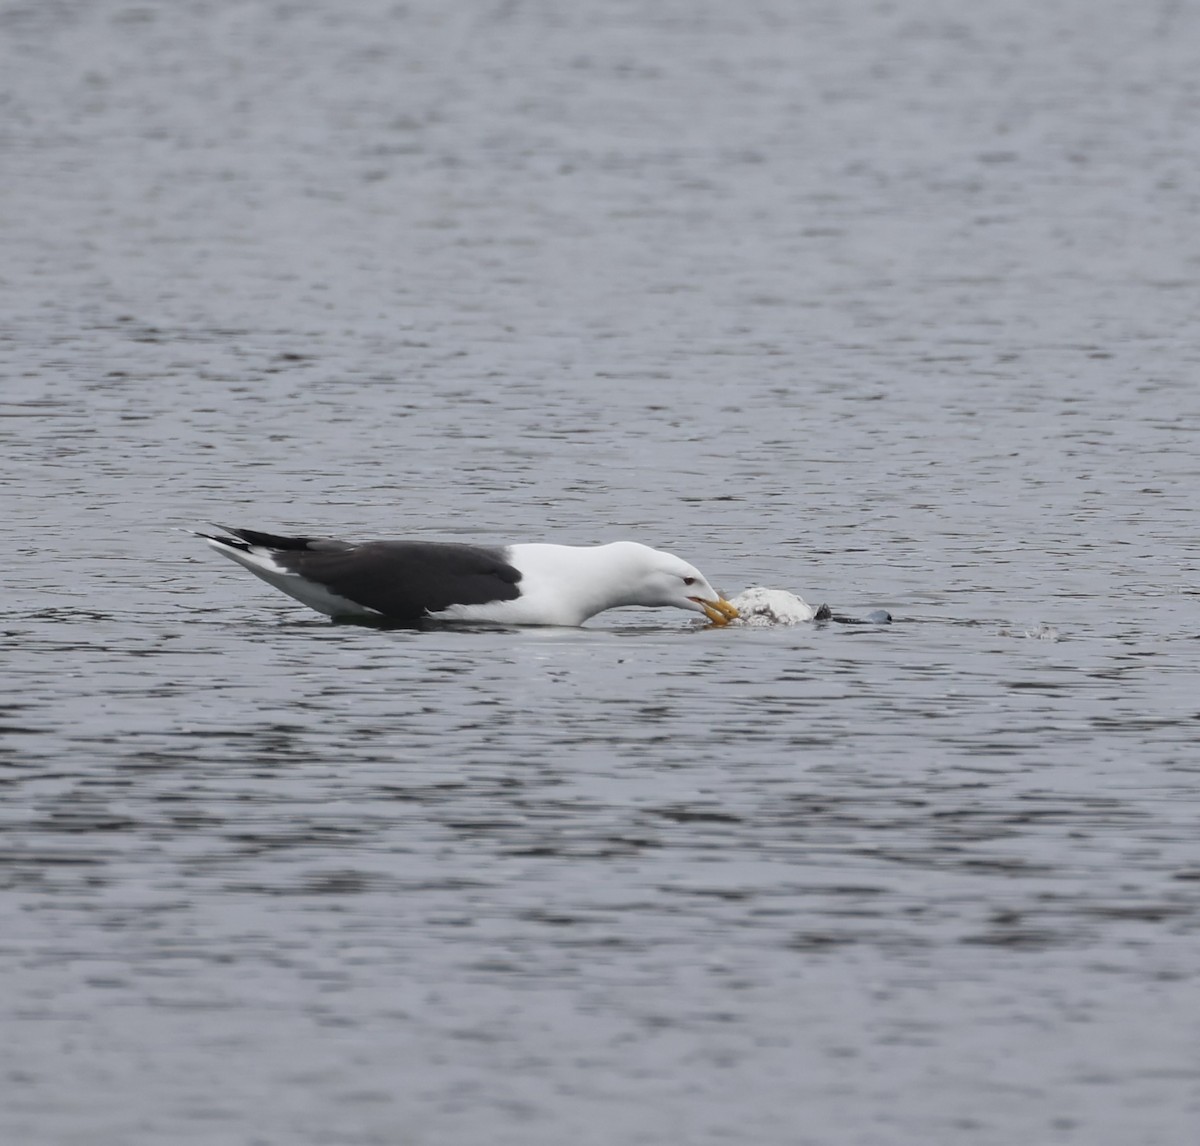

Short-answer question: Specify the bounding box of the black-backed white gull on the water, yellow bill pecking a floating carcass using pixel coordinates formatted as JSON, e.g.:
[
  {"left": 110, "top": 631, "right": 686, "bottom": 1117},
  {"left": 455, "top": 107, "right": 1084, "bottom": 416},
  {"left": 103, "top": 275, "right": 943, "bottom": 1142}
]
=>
[{"left": 196, "top": 526, "right": 738, "bottom": 625}]
